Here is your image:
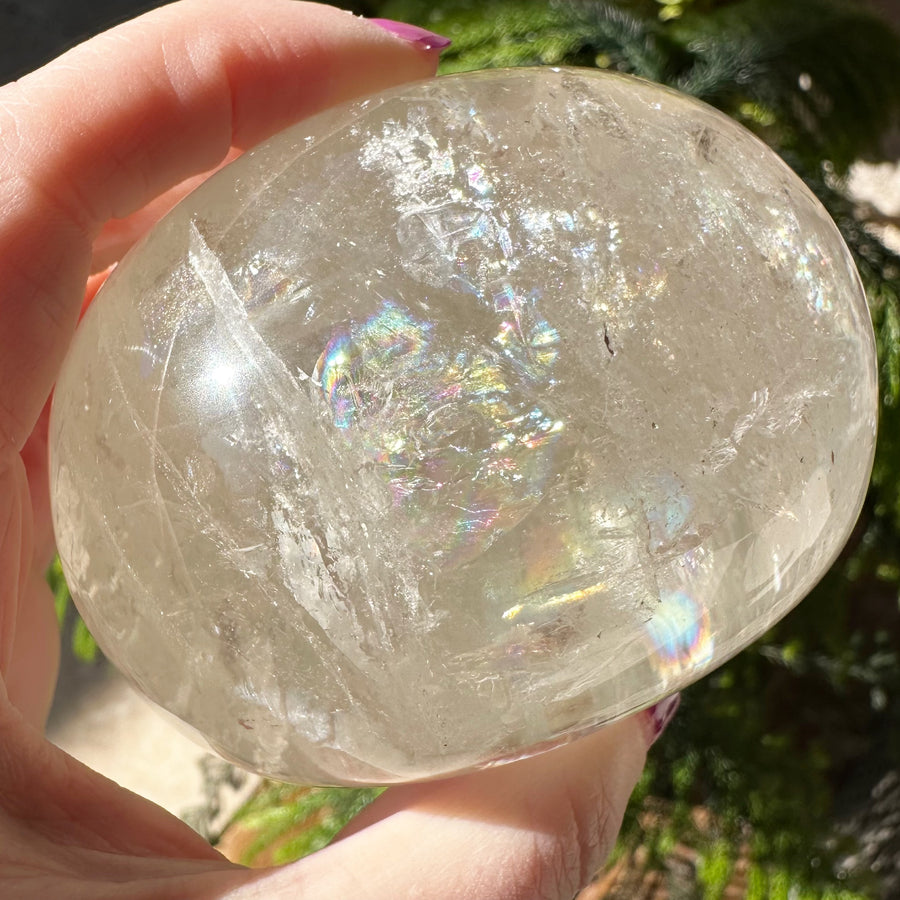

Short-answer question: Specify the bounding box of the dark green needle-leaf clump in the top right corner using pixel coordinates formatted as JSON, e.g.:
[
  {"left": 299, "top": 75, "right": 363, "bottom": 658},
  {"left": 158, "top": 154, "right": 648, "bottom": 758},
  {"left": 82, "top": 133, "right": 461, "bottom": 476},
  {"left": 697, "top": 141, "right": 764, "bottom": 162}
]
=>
[{"left": 670, "top": 0, "right": 900, "bottom": 171}]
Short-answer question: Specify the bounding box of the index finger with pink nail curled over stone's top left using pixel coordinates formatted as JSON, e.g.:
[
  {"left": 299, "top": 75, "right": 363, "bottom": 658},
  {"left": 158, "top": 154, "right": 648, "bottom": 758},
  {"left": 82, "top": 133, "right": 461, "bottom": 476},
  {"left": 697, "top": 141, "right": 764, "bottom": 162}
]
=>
[{"left": 0, "top": 0, "right": 437, "bottom": 450}]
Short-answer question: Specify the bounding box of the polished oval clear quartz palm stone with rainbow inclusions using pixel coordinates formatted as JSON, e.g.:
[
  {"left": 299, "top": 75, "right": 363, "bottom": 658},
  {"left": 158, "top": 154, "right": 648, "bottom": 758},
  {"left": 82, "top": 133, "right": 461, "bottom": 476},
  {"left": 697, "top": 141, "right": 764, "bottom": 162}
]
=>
[{"left": 52, "top": 69, "right": 876, "bottom": 783}]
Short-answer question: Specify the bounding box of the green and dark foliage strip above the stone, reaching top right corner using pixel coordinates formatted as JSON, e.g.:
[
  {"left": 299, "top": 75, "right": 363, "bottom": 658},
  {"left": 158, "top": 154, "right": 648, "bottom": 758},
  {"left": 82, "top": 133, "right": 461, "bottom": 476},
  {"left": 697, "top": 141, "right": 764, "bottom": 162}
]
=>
[{"left": 378, "top": 0, "right": 900, "bottom": 171}]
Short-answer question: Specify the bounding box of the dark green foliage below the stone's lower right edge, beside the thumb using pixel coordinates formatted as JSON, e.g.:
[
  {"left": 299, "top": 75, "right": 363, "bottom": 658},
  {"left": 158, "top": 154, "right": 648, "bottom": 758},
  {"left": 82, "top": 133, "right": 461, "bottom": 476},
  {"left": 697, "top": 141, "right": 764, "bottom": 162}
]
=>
[{"left": 623, "top": 511, "right": 900, "bottom": 898}]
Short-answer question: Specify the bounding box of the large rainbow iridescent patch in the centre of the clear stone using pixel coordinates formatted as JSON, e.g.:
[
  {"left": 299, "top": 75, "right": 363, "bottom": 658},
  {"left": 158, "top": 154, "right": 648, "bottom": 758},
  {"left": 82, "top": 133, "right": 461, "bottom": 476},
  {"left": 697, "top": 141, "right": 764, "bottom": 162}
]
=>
[{"left": 312, "top": 302, "right": 564, "bottom": 568}]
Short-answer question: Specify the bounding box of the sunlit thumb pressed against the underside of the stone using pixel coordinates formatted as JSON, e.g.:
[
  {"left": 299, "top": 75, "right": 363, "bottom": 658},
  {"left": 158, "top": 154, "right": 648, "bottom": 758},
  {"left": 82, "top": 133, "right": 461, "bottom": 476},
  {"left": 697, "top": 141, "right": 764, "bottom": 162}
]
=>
[{"left": 229, "top": 711, "right": 660, "bottom": 900}]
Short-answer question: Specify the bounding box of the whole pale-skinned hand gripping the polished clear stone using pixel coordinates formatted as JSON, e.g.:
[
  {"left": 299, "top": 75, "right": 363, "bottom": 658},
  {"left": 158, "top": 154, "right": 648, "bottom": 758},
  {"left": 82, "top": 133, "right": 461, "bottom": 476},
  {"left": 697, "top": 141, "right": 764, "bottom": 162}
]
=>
[{"left": 0, "top": 0, "right": 655, "bottom": 900}]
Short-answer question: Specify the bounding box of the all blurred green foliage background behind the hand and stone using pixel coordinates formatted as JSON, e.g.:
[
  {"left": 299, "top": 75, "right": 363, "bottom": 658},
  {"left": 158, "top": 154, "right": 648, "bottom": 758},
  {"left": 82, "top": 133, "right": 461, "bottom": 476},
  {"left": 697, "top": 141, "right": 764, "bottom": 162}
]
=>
[{"left": 21, "top": 0, "right": 900, "bottom": 900}]
